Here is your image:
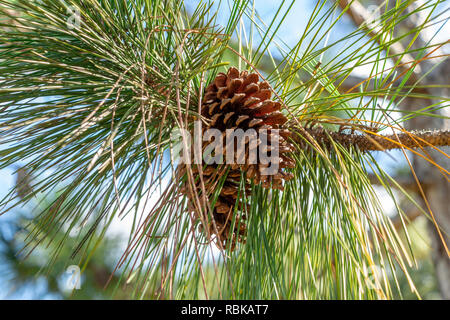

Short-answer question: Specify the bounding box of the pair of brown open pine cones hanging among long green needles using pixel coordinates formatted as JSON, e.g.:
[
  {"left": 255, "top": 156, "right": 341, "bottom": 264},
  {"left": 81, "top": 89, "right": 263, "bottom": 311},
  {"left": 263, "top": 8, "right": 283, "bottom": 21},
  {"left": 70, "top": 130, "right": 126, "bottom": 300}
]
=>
[{"left": 180, "top": 67, "right": 295, "bottom": 249}]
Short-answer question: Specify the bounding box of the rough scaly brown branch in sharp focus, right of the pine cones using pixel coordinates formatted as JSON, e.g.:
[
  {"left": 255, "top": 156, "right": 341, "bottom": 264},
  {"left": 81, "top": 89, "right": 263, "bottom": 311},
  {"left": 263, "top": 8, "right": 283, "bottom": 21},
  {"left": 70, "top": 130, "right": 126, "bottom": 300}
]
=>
[{"left": 291, "top": 127, "right": 450, "bottom": 152}]
